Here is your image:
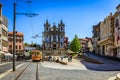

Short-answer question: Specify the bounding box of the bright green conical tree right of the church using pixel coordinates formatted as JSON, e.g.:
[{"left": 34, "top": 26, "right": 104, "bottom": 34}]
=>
[{"left": 70, "top": 35, "right": 81, "bottom": 52}]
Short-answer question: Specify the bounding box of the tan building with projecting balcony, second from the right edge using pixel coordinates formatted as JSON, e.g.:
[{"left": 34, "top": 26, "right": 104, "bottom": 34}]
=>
[{"left": 98, "top": 13, "right": 114, "bottom": 56}]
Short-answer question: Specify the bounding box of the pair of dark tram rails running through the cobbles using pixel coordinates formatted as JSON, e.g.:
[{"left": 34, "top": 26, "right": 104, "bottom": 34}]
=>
[{"left": 15, "top": 62, "right": 39, "bottom": 80}]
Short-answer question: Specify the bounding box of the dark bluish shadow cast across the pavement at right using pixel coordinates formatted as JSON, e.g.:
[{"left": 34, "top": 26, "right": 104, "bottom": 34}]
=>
[{"left": 81, "top": 55, "right": 120, "bottom": 71}]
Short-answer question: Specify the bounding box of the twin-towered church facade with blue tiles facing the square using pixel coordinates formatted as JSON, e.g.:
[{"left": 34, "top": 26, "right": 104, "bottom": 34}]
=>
[{"left": 42, "top": 20, "right": 65, "bottom": 50}]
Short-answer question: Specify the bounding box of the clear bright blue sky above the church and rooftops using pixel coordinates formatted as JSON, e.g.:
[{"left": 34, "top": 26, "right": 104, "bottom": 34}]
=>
[{"left": 0, "top": 0, "right": 120, "bottom": 44}]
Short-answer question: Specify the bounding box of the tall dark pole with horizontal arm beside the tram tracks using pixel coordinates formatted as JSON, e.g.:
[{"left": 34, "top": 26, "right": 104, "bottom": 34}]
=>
[{"left": 13, "top": 2, "right": 38, "bottom": 71}]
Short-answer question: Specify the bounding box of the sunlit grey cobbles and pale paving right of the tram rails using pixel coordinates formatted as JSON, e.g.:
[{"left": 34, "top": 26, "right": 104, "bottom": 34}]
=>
[{"left": 39, "top": 62, "right": 120, "bottom": 80}]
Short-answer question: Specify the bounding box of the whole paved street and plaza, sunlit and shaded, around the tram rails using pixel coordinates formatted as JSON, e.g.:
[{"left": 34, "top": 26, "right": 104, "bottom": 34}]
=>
[{"left": 0, "top": 55, "right": 120, "bottom": 80}]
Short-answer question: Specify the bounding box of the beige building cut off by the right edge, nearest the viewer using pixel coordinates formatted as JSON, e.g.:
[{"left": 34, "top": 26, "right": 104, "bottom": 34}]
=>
[{"left": 113, "top": 4, "right": 120, "bottom": 58}]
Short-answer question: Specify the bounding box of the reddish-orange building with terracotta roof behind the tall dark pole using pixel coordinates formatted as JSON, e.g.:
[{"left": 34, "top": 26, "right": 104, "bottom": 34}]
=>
[{"left": 8, "top": 32, "right": 24, "bottom": 55}]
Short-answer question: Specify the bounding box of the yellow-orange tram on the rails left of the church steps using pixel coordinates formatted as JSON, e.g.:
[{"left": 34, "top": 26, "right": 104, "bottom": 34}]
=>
[{"left": 32, "top": 50, "right": 42, "bottom": 61}]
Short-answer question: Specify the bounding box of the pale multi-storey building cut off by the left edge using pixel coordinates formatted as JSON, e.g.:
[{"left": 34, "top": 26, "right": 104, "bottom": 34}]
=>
[{"left": 0, "top": 3, "right": 8, "bottom": 53}]
